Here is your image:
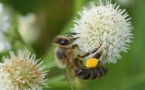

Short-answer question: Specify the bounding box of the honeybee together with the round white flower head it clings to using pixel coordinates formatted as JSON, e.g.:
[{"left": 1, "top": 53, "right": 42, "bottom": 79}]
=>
[{"left": 54, "top": 0, "right": 133, "bottom": 89}]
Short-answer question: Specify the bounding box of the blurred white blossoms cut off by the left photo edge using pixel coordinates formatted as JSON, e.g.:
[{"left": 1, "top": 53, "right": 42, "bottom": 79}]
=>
[{"left": 0, "top": 3, "right": 11, "bottom": 52}]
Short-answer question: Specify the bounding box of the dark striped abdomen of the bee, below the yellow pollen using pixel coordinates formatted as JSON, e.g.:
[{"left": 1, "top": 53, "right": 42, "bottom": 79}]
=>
[{"left": 76, "top": 66, "right": 107, "bottom": 80}]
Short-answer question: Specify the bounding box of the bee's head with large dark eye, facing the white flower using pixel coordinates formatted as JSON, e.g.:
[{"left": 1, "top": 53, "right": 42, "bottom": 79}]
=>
[{"left": 53, "top": 36, "right": 73, "bottom": 46}]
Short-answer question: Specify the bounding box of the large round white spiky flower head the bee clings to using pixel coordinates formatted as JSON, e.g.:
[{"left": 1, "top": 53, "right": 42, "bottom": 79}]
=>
[{"left": 71, "top": 0, "right": 133, "bottom": 63}]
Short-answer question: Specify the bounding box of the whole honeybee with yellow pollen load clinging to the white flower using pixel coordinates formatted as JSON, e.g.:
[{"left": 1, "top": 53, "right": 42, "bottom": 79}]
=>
[{"left": 53, "top": 33, "right": 107, "bottom": 88}]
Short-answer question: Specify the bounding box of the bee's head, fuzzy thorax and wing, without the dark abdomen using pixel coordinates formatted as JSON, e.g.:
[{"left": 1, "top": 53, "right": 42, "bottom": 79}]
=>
[{"left": 53, "top": 35, "right": 83, "bottom": 90}]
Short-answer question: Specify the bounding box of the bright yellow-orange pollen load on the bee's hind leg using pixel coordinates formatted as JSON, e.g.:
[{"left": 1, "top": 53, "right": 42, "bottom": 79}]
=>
[{"left": 86, "top": 58, "right": 99, "bottom": 68}]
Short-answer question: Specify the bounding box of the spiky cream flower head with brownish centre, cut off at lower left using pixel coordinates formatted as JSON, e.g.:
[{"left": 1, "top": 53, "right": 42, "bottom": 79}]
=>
[{"left": 0, "top": 51, "right": 46, "bottom": 90}]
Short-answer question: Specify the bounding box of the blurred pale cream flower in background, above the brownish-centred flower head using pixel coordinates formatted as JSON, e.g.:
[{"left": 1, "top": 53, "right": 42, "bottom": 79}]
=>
[{"left": 18, "top": 13, "right": 39, "bottom": 43}]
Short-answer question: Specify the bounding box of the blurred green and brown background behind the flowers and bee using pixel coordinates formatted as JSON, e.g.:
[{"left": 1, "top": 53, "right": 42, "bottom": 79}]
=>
[{"left": 0, "top": 0, "right": 145, "bottom": 90}]
